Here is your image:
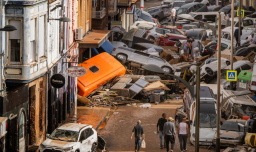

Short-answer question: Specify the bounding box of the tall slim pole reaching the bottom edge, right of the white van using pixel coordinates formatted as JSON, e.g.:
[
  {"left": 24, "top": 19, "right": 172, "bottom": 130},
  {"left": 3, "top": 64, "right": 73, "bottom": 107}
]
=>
[{"left": 216, "top": 12, "right": 221, "bottom": 152}]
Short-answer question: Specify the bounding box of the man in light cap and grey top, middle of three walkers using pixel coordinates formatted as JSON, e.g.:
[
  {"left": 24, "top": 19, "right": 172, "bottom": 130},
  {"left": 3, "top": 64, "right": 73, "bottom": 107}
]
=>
[{"left": 163, "top": 117, "right": 176, "bottom": 152}]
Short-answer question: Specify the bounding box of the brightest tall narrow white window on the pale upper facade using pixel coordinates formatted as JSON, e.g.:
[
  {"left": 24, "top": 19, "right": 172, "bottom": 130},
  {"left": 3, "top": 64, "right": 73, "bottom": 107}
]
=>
[{"left": 38, "top": 15, "right": 46, "bottom": 57}]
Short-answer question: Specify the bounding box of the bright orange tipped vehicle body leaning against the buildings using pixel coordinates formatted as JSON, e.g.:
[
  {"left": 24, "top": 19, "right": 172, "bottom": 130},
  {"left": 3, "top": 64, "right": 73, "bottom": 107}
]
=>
[{"left": 77, "top": 52, "right": 126, "bottom": 97}]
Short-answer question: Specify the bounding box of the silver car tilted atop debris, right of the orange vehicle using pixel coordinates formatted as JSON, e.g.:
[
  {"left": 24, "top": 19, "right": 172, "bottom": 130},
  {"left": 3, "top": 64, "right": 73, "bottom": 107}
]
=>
[{"left": 111, "top": 47, "right": 175, "bottom": 73}]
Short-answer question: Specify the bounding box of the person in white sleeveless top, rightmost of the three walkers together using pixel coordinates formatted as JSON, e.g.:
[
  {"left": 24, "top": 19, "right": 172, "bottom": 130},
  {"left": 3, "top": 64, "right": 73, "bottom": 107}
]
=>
[{"left": 178, "top": 118, "right": 189, "bottom": 152}]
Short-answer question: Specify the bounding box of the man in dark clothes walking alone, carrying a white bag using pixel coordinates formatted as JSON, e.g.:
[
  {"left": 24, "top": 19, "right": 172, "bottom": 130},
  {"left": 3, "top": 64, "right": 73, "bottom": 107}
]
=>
[{"left": 131, "top": 120, "right": 145, "bottom": 152}]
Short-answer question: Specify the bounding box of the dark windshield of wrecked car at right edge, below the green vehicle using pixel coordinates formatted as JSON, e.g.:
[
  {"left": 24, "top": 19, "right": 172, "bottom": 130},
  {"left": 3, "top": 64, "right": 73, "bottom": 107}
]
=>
[{"left": 233, "top": 104, "right": 256, "bottom": 118}]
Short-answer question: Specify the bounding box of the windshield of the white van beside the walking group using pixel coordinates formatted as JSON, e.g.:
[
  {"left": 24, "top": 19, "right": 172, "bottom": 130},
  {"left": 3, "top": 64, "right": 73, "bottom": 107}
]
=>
[{"left": 194, "top": 113, "right": 217, "bottom": 128}]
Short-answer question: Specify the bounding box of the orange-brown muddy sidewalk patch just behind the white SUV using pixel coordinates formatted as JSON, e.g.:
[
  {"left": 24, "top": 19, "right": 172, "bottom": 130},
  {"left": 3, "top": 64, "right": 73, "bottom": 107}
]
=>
[{"left": 77, "top": 106, "right": 110, "bottom": 130}]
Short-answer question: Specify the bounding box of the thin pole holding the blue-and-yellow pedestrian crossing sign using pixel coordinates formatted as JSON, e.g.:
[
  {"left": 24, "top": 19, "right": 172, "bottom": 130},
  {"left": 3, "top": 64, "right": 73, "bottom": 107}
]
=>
[{"left": 230, "top": 0, "right": 235, "bottom": 89}]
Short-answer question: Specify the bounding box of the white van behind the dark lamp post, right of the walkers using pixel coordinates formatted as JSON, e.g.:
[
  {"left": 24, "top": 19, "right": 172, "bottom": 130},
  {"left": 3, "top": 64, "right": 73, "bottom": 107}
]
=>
[{"left": 183, "top": 85, "right": 217, "bottom": 145}]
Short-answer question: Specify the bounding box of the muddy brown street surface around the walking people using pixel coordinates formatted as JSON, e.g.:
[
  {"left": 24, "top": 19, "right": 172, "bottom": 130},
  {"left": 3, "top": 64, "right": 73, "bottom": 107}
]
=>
[{"left": 99, "top": 99, "right": 218, "bottom": 152}]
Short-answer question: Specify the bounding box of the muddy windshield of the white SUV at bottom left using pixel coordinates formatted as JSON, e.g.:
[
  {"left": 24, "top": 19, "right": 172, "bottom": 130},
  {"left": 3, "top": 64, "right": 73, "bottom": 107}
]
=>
[{"left": 50, "top": 129, "right": 79, "bottom": 142}]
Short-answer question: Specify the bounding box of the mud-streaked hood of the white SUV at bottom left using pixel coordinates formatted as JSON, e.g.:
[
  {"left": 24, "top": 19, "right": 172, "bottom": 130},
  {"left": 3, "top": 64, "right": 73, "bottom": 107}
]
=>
[{"left": 42, "top": 138, "right": 77, "bottom": 149}]
